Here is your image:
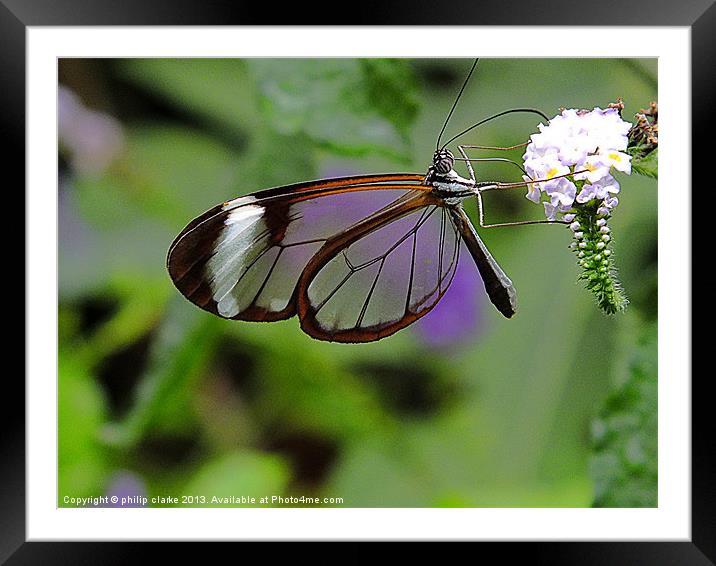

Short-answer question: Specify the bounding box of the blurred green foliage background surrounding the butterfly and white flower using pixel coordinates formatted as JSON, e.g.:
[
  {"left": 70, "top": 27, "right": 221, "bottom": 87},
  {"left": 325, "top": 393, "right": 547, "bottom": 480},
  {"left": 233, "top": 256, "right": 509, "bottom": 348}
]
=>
[{"left": 58, "top": 59, "right": 657, "bottom": 507}]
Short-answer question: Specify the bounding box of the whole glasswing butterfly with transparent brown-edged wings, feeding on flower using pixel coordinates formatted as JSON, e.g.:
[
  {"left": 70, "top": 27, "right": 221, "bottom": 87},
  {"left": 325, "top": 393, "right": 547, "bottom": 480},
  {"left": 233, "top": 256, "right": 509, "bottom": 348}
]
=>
[{"left": 167, "top": 60, "right": 560, "bottom": 343}]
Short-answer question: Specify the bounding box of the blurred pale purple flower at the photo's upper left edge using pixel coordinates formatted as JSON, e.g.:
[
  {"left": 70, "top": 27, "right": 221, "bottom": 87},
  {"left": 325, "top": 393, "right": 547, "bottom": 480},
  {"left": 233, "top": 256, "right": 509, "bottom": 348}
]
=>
[{"left": 57, "top": 85, "right": 125, "bottom": 175}]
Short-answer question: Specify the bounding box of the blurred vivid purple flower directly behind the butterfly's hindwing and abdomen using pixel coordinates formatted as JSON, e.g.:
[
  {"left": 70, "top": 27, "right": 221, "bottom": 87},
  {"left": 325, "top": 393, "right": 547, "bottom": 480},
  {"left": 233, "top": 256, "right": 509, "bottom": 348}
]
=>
[{"left": 415, "top": 254, "right": 485, "bottom": 348}]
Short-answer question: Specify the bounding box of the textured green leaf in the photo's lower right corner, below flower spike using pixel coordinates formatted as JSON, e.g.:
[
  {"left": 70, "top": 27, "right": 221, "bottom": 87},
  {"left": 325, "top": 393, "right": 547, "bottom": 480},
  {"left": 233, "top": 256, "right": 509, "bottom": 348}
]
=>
[{"left": 590, "top": 324, "right": 658, "bottom": 507}]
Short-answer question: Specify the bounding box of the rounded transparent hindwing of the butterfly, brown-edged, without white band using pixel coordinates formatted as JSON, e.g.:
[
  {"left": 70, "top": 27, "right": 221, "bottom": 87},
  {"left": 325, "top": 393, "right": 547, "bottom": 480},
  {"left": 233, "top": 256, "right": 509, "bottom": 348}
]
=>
[{"left": 298, "top": 194, "right": 461, "bottom": 342}]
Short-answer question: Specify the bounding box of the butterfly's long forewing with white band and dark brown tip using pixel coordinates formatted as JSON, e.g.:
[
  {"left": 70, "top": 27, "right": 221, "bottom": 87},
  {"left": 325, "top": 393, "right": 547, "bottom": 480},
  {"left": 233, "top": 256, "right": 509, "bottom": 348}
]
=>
[{"left": 167, "top": 175, "right": 427, "bottom": 321}]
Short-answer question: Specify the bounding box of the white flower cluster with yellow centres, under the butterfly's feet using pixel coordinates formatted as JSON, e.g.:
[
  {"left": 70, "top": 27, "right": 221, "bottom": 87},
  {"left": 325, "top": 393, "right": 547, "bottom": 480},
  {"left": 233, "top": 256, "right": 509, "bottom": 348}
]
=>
[{"left": 523, "top": 108, "right": 631, "bottom": 220}]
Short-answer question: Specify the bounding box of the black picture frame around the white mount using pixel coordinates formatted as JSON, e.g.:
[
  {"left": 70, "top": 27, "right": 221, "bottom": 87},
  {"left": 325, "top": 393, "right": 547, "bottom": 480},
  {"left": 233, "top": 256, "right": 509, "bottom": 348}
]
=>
[{"left": 7, "top": 0, "right": 704, "bottom": 565}]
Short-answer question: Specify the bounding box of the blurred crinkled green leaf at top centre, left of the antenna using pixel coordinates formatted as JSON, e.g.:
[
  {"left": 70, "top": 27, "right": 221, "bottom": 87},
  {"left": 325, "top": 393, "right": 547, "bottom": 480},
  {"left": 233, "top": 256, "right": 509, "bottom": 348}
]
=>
[{"left": 248, "top": 59, "right": 415, "bottom": 161}]
